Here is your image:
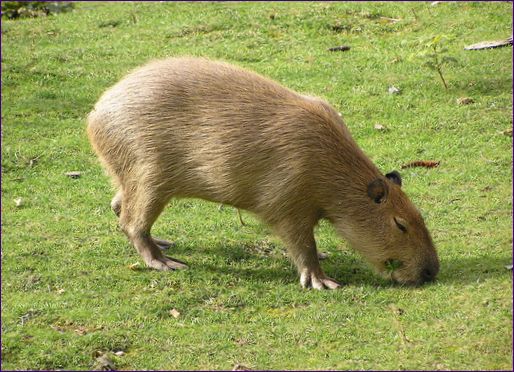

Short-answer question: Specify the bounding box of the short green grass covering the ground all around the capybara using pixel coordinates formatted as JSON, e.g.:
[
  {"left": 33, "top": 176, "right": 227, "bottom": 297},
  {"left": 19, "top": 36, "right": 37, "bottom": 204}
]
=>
[{"left": 2, "top": 2, "right": 512, "bottom": 370}]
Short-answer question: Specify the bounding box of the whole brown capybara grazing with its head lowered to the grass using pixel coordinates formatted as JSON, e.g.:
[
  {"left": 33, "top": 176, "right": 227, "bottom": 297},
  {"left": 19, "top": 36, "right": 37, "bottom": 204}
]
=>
[{"left": 87, "top": 57, "right": 439, "bottom": 289}]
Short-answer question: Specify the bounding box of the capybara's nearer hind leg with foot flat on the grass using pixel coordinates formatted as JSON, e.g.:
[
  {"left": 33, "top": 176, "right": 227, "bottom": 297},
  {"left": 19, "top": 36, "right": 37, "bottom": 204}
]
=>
[{"left": 120, "top": 182, "right": 187, "bottom": 270}]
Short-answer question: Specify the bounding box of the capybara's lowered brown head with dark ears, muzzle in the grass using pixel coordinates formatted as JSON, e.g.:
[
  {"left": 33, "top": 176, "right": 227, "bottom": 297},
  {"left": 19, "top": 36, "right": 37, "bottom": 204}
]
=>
[{"left": 336, "top": 171, "right": 439, "bottom": 285}]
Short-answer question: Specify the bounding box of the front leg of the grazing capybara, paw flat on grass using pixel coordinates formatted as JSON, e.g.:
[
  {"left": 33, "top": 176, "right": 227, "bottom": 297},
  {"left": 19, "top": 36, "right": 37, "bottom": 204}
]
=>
[{"left": 277, "top": 221, "right": 340, "bottom": 289}]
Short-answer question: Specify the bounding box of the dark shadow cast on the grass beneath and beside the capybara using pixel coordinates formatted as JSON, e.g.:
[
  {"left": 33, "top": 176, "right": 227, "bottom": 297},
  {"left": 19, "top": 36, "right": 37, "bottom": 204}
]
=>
[{"left": 170, "top": 243, "right": 512, "bottom": 288}]
